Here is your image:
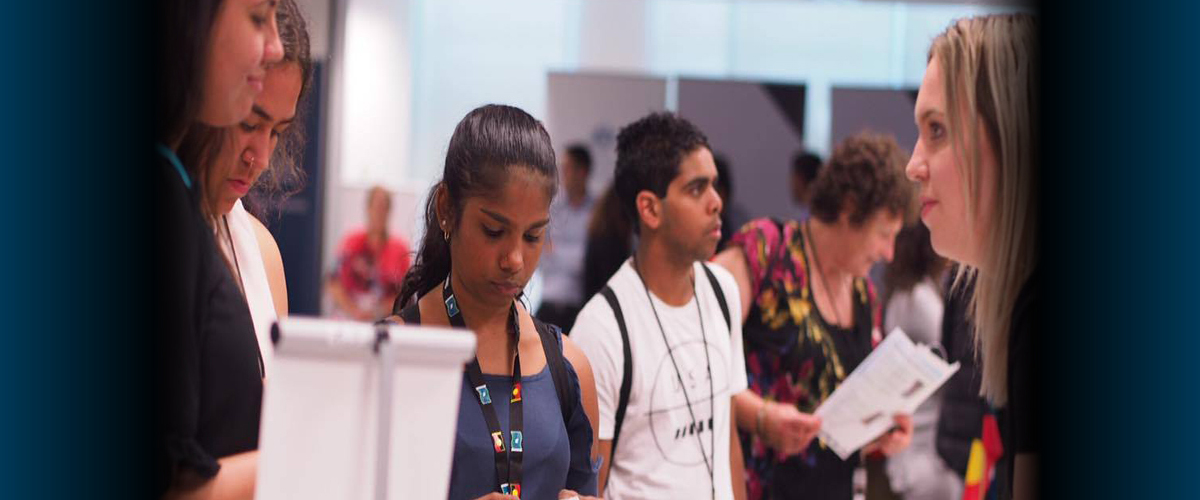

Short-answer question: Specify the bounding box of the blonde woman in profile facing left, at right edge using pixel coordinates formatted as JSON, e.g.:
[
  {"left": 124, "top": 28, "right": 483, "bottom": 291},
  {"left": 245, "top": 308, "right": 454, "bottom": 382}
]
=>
[{"left": 907, "top": 14, "right": 1039, "bottom": 499}]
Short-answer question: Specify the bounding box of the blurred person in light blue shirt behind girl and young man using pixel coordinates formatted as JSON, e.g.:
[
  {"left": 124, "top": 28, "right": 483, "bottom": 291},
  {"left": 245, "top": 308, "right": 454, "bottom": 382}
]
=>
[{"left": 538, "top": 144, "right": 594, "bottom": 332}]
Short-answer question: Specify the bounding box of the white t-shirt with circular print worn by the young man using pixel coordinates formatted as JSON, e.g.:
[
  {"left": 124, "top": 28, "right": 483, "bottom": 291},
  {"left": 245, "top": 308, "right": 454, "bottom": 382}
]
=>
[{"left": 571, "top": 260, "right": 746, "bottom": 499}]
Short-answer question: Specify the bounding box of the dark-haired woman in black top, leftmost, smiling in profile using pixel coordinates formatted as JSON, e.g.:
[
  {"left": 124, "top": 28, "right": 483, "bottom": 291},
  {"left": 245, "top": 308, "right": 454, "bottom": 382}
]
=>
[{"left": 149, "top": 0, "right": 282, "bottom": 499}]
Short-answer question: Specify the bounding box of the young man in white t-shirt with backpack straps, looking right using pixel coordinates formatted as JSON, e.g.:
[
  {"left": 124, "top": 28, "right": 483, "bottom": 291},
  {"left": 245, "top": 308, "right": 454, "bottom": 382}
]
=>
[{"left": 571, "top": 113, "right": 746, "bottom": 500}]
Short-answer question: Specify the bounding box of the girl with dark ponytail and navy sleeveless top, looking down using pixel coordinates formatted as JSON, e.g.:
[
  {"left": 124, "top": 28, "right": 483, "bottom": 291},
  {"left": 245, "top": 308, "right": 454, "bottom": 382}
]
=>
[{"left": 390, "top": 106, "right": 598, "bottom": 499}]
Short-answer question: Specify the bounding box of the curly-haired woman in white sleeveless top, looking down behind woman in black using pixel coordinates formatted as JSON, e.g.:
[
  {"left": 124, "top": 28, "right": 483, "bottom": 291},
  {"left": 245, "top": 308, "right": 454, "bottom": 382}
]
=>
[{"left": 180, "top": 0, "right": 312, "bottom": 373}]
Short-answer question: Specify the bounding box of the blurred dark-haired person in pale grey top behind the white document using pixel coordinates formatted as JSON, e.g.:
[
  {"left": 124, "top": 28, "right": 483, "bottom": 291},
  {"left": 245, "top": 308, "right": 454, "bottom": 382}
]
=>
[{"left": 883, "top": 222, "right": 962, "bottom": 500}]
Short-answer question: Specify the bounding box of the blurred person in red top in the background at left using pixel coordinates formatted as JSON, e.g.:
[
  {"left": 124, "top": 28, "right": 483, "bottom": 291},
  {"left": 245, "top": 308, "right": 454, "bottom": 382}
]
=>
[{"left": 325, "top": 186, "right": 409, "bottom": 321}]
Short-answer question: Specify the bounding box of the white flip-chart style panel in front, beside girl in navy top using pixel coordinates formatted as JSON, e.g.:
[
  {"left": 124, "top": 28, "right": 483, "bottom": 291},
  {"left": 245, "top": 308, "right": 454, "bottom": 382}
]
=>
[{"left": 256, "top": 318, "right": 475, "bottom": 500}]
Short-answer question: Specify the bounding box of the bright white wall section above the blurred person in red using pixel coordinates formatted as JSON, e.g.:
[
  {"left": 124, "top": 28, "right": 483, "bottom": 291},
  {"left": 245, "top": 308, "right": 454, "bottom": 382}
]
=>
[{"left": 321, "top": 0, "right": 415, "bottom": 299}]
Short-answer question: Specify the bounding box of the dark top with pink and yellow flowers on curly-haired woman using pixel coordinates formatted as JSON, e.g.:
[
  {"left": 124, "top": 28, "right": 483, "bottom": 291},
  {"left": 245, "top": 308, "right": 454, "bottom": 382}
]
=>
[{"left": 731, "top": 218, "right": 881, "bottom": 500}]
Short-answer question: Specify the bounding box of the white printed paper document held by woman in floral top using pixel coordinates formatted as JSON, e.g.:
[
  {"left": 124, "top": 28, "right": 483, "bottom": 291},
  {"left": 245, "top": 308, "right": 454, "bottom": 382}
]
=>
[{"left": 816, "top": 329, "right": 959, "bottom": 459}]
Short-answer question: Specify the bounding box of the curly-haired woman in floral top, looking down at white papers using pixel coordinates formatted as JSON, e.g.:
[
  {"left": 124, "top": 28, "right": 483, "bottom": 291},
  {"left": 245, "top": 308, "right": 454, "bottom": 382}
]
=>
[{"left": 715, "top": 133, "right": 913, "bottom": 500}]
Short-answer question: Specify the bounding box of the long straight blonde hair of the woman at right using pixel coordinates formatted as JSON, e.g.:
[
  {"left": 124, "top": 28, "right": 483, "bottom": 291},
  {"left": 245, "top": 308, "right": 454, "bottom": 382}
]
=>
[{"left": 929, "top": 14, "right": 1038, "bottom": 406}]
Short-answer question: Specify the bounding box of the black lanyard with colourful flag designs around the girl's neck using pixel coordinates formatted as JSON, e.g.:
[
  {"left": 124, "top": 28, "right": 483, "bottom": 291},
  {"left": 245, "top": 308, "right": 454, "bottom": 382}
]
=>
[{"left": 442, "top": 277, "right": 524, "bottom": 498}]
